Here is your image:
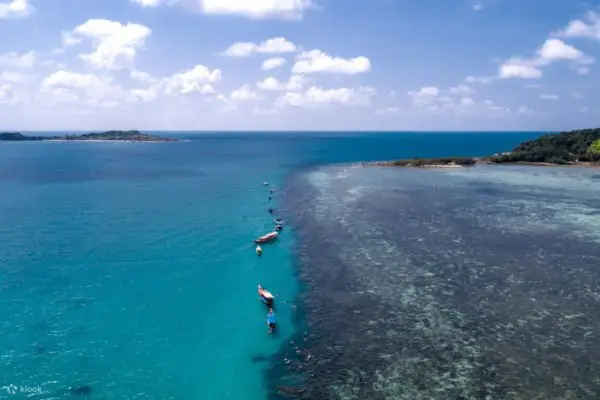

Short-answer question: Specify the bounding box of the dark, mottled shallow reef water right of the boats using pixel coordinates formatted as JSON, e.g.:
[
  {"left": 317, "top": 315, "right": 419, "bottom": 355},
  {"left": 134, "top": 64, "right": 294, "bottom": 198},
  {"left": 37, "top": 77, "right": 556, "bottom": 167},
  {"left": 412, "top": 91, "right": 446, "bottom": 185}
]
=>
[{"left": 270, "top": 166, "right": 600, "bottom": 400}]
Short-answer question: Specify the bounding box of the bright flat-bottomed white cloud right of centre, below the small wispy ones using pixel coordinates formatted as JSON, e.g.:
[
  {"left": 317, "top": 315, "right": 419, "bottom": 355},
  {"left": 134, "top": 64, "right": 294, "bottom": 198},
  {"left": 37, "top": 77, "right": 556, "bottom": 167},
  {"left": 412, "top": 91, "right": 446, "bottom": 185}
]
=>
[{"left": 292, "top": 50, "right": 371, "bottom": 75}]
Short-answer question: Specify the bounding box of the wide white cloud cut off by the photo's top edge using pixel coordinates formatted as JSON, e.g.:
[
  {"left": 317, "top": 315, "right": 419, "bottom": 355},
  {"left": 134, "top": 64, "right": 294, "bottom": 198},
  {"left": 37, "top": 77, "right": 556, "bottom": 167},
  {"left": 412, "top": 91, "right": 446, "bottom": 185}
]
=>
[{"left": 200, "top": 0, "right": 314, "bottom": 19}]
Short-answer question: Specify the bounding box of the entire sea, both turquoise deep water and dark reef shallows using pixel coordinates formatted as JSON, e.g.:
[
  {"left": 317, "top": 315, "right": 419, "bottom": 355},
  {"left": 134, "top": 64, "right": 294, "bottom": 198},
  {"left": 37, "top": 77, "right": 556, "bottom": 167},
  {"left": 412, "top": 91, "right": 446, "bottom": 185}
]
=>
[{"left": 5, "top": 132, "right": 600, "bottom": 400}]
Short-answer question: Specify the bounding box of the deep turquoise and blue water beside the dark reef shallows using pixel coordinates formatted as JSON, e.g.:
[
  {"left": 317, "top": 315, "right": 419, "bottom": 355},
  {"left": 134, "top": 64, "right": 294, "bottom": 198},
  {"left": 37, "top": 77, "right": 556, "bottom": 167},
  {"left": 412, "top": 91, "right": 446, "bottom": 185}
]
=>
[{"left": 0, "top": 133, "right": 537, "bottom": 400}]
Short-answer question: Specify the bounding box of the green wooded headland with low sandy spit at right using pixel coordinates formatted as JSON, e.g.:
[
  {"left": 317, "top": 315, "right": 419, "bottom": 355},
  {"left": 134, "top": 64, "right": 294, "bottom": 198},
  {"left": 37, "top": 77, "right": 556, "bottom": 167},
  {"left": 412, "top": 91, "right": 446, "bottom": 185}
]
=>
[{"left": 370, "top": 128, "right": 600, "bottom": 168}]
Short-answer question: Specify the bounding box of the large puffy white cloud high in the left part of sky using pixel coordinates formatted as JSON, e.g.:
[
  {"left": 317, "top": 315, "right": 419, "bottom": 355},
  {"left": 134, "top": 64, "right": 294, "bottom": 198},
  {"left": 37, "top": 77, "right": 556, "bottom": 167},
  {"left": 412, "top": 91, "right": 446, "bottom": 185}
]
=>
[{"left": 63, "top": 19, "right": 152, "bottom": 69}]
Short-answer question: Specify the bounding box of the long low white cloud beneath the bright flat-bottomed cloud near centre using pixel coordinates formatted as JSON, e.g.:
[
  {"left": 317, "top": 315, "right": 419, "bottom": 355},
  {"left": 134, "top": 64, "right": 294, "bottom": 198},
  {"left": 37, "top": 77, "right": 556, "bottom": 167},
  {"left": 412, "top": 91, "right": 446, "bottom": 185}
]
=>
[{"left": 275, "top": 86, "right": 375, "bottom": 108}]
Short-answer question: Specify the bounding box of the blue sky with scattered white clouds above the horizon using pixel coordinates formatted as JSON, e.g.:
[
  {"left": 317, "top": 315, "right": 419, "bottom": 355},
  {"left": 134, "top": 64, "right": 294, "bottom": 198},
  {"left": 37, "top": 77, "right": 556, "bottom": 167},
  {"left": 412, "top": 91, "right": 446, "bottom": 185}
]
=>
[{"left": 0, "top": 0, "right": 600, "bottom": 131}]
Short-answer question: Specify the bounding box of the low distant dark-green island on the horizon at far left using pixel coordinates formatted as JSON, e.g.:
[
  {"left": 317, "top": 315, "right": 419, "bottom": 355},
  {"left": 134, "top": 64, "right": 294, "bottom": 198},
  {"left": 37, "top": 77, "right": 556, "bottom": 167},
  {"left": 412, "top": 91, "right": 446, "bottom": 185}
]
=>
[{"left": 0, "top": 131, "right": 178, "bottom": 142}]
